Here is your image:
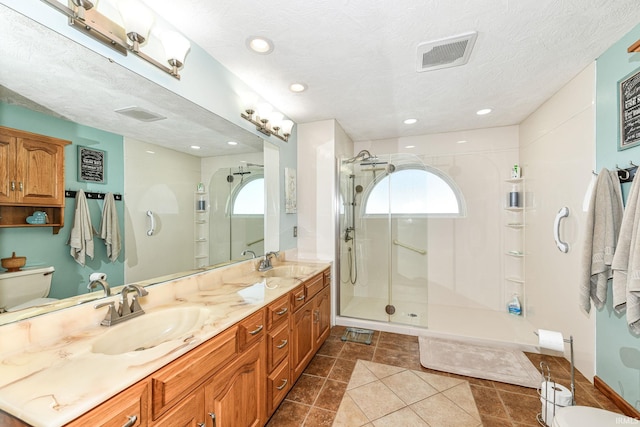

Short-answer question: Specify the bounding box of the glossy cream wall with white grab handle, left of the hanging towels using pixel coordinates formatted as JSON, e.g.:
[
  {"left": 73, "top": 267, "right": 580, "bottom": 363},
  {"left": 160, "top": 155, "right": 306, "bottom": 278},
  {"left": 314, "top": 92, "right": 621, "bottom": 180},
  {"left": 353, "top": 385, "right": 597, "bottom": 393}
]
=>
[{"left": 520, "top": 64, "right": 595, "bottom": 379}]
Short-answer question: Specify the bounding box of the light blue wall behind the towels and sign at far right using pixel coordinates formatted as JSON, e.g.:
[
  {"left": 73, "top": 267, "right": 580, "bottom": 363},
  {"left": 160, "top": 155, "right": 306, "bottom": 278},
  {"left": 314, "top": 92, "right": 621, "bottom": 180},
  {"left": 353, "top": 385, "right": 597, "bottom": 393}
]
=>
[{"left": 596, "top": 25, "right": 640, "bottom": 409}]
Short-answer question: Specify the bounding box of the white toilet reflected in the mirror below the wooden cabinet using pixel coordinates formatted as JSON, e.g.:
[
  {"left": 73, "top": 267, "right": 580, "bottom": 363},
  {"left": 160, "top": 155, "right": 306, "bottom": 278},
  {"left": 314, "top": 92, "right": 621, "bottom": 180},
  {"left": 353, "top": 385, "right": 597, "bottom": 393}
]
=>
[{"left": 0, "top": 267, "right": 56, "bottom": 312}]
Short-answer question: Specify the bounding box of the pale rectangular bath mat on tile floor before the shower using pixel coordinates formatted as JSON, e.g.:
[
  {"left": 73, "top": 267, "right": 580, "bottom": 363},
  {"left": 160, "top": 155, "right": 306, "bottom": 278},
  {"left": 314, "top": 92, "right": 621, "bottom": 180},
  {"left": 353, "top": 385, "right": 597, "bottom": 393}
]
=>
[{"left": 419, "top": 337, "right": 542, "bottom": 388}]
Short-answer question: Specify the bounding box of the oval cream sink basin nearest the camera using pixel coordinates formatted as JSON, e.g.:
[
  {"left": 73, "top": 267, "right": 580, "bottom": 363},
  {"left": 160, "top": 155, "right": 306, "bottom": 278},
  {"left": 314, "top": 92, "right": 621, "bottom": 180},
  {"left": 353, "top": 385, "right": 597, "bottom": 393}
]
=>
[{"left": 91, "top": 307, "right": 208, "bottom": 355}]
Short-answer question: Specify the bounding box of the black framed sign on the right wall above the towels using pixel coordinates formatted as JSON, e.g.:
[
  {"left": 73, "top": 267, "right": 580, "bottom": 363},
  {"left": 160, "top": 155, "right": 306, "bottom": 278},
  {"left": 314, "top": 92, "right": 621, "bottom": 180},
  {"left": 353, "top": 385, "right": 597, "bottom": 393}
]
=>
[{"left": 618, "top": 71, "right": 640, "bottom": 150}]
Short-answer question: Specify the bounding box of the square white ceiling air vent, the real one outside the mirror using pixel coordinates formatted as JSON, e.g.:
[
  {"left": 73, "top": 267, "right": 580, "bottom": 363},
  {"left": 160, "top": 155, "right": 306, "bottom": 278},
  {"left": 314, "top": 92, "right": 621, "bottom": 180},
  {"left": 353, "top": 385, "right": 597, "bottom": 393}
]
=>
[{"left": 418, "top": 31, "right": 478, "bottom": 71}]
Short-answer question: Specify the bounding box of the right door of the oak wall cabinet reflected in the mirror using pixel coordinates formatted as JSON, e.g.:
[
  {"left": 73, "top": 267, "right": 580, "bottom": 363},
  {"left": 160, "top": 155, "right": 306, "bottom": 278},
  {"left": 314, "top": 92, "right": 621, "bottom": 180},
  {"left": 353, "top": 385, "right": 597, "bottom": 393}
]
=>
[{"left": 16, "top": 138, "right": 64, "bottom": 206}]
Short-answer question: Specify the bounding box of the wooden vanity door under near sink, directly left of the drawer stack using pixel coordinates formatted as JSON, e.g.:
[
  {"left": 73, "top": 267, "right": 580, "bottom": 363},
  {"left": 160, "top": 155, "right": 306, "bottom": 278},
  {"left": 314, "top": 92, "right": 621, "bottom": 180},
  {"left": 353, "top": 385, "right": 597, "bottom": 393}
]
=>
[{"left": 204, "top": 340, "right": 266, "bottom": 427}]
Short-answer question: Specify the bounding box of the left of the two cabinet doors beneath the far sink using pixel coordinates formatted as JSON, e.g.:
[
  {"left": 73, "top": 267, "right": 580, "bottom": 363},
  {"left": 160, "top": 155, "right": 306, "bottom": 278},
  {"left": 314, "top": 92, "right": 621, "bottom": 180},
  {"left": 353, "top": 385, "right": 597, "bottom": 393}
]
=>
[{"left": 289, "top": 300, "right": 314, "bottom": 382}]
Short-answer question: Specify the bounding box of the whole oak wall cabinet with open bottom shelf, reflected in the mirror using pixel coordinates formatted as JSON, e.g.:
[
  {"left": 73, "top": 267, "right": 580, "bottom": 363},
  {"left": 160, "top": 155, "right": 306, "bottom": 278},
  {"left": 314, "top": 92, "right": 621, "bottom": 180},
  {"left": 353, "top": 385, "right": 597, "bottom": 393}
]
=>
[{"left": 0, "top": 126, "right": 71, "bottom": 234}]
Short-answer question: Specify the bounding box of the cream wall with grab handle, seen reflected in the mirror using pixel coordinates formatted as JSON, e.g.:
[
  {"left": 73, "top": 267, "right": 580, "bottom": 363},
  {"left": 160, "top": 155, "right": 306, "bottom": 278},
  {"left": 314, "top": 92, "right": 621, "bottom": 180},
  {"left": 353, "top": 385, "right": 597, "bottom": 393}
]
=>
[{"left": 124, "top": 138, "right": 200, "bottom": 283}]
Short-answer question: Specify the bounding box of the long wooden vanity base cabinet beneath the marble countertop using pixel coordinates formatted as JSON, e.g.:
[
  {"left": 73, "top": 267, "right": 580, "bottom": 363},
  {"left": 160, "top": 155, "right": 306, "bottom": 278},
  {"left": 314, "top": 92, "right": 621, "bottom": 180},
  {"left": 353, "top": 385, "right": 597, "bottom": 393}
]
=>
[{"left": 67, "top": 269, "right": 331, "bottom": 427}]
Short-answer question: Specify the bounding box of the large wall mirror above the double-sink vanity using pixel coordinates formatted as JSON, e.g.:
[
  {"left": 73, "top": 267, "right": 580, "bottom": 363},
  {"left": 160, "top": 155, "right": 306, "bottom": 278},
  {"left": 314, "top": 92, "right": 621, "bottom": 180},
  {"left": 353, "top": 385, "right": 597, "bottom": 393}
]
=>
[{"left": 0, "top": 5, "right": 279, "bottom": 324}]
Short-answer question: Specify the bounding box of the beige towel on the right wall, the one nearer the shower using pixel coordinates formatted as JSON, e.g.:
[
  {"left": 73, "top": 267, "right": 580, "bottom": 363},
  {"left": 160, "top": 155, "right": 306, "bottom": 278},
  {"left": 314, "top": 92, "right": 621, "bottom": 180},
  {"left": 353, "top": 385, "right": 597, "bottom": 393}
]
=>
[{"left": 579, "top": 168, "right": 623, "bottom": 312}]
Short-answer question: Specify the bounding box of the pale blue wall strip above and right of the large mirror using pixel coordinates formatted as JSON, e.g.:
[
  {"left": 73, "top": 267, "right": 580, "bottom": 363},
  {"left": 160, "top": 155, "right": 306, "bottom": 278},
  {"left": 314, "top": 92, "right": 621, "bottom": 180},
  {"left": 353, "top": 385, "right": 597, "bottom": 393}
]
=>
[{"left": 3, "top": 0, "right": 298, "bottom": 254}]
